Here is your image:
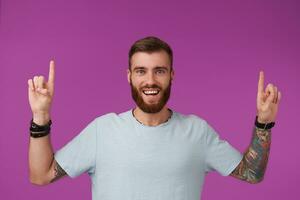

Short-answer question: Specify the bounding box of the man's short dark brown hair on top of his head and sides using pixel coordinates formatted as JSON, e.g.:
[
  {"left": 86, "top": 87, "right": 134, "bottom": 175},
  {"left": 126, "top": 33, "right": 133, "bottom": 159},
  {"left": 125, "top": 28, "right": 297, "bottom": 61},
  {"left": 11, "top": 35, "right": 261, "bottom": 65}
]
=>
[{"left": 129, "top": 36, "right": 173, "bottom": 69}]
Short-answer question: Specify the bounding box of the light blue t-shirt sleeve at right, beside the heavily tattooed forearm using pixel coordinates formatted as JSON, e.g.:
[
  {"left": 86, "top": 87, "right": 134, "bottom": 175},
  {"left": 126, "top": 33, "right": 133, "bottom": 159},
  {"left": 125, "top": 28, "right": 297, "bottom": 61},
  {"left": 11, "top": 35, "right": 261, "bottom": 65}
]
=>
[{"left": 205, "top": 123, "right": 243, "bottom": 176}]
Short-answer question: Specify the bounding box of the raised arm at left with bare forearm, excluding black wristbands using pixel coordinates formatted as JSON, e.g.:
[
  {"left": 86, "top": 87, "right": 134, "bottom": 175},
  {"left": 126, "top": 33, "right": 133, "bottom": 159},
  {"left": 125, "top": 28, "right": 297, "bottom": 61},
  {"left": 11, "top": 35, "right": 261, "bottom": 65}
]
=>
[{"left": 28, "top": 61, "right": 66, "bottom": 185}]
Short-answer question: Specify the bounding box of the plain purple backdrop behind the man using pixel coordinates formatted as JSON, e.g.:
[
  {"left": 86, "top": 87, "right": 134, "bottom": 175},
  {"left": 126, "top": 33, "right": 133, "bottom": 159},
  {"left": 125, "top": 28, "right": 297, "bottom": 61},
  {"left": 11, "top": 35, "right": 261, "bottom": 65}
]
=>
[{"left": 0, "top": 0, "right": 300, "bottom": 200}]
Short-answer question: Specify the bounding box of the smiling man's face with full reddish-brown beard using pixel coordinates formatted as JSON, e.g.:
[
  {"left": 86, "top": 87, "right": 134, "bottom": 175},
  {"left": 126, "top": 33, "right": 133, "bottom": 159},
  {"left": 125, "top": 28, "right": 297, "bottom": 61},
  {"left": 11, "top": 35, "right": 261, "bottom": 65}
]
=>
[{"left": 127, "top": 51, "right": 174, "bottom": 113}]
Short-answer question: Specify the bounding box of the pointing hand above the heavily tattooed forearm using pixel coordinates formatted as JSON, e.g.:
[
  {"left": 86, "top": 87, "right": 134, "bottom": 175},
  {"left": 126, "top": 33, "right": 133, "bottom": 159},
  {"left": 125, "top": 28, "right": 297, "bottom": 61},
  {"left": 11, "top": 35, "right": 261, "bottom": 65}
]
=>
[{"left": 256, "top": 71, "right": 281, "bottom": 124}]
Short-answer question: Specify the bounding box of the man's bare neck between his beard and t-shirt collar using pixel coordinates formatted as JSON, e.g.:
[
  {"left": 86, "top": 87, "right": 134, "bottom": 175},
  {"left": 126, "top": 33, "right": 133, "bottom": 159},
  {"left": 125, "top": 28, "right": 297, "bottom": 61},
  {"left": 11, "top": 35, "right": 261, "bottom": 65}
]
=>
[{"left": 133, "top": 106, "right": 172, "bottom": 126}]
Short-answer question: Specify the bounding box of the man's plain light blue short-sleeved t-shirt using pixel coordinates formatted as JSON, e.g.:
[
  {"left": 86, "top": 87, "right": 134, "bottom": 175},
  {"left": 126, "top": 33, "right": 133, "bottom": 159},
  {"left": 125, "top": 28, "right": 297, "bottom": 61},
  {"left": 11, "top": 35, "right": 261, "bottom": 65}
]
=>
[{"left": 55, "top": 110, "right": 242, "bottom": 200}]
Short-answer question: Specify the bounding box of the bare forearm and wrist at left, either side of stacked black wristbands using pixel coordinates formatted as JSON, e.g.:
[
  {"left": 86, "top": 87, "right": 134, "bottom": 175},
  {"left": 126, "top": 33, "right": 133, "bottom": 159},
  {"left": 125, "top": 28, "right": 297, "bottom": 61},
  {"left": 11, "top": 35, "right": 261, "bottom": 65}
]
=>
[{"left": 29, "top": 114, "right": 53, "bottom": 184}]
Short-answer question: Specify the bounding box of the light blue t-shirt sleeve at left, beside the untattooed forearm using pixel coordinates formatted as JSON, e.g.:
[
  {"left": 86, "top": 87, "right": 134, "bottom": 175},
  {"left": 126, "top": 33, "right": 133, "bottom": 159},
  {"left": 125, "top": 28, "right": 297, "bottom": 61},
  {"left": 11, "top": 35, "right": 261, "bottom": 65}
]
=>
[{"left": 54, "top": 120, "right": 97, "bottom": 178}]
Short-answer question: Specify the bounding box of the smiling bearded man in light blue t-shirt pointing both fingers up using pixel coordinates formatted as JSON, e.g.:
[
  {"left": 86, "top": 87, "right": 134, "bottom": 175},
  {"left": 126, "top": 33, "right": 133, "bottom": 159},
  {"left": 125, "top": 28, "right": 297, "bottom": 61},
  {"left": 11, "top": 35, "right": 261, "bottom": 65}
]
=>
[{"left": 28, "top": 37, "right": 281, "bottom": 200}]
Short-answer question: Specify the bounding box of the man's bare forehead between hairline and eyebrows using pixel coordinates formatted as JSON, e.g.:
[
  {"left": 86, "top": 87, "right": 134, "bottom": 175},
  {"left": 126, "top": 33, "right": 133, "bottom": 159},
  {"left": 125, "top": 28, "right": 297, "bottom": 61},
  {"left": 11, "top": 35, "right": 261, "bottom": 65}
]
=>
[{"left": 131, "top": 51, "right": 170, "bottom": 69}]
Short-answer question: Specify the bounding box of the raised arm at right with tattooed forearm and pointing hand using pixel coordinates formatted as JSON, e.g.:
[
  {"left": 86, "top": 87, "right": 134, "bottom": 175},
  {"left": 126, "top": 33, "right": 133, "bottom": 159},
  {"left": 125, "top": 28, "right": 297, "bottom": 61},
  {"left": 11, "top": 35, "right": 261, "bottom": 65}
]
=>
[{"left": 231, "top": 72, "right": 281, "bottom": 183}]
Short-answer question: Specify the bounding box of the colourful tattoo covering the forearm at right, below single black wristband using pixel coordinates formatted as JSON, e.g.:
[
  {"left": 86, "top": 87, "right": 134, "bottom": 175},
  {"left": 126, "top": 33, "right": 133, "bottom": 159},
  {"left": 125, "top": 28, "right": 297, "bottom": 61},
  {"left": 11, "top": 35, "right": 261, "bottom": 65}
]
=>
[{"left": 231, "top": 127, "right": 271, "bottom": 183}]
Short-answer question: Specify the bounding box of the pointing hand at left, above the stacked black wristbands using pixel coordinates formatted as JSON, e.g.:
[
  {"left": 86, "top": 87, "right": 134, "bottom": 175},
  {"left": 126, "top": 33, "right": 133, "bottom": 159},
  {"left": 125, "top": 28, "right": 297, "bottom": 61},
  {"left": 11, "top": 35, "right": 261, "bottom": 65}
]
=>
[{"left": 28, "top": 60, "right": 55, "bottom": 115}]
